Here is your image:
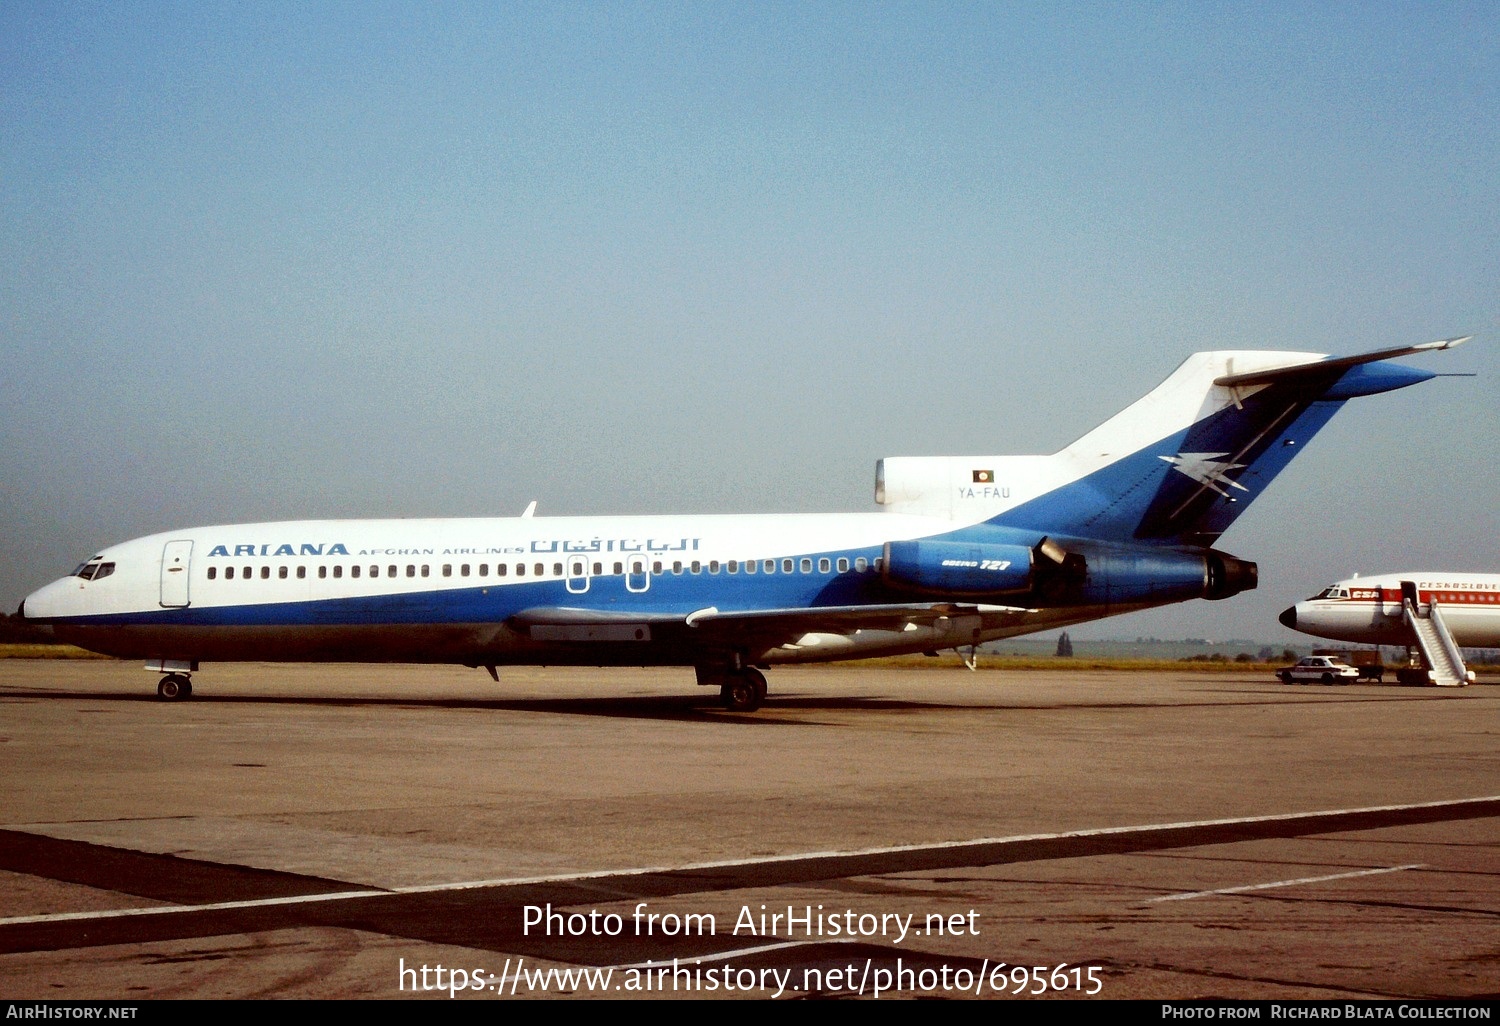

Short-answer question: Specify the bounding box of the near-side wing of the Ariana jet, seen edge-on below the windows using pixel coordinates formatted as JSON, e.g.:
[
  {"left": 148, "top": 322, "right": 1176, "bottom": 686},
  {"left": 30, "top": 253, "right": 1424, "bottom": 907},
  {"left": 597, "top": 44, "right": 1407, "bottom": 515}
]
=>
[{"left": 510, "top": 602, "right": 1032, "bottom": 648}]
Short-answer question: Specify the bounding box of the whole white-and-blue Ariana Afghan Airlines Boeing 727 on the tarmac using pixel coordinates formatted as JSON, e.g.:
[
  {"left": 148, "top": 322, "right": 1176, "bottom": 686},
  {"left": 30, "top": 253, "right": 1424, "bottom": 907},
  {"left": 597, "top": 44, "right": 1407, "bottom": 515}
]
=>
[{"left": 20, "top": 339, "right": 1467, "bottom": 711}]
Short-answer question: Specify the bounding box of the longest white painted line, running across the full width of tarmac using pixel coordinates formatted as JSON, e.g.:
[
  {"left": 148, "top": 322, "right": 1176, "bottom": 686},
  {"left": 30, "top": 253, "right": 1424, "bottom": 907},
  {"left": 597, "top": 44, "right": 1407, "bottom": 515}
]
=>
[{"left": 0, "top": 795, "right": 1500, "bottom": 927}]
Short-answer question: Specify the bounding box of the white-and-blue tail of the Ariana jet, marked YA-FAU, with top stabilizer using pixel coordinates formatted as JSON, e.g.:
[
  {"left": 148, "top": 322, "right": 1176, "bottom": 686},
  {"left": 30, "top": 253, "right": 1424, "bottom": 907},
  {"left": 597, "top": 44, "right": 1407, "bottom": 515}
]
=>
[{"left": 881, "top": 339, "right": 1467, "bottom": 546}]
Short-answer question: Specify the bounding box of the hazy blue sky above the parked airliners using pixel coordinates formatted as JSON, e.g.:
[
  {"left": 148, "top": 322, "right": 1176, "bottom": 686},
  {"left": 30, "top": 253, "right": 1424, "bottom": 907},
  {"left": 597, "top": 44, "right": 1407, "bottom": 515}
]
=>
[{"left": 0, "top": 0, "right": 1500, "bottom": 641}]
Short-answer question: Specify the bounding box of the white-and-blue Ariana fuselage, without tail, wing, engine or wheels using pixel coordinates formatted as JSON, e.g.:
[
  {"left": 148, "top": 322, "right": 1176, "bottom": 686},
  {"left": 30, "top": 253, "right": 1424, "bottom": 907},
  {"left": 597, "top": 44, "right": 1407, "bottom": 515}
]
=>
[{"left": 23, "top": 513, "right": 1176, "bottom": 666}]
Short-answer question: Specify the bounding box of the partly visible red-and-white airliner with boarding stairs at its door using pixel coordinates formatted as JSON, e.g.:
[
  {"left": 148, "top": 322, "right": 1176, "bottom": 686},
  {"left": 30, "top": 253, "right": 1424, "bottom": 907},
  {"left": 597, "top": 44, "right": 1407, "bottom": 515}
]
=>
[{"left": 1280, "top": 570, "right": 1500, "bottom": 686}]
